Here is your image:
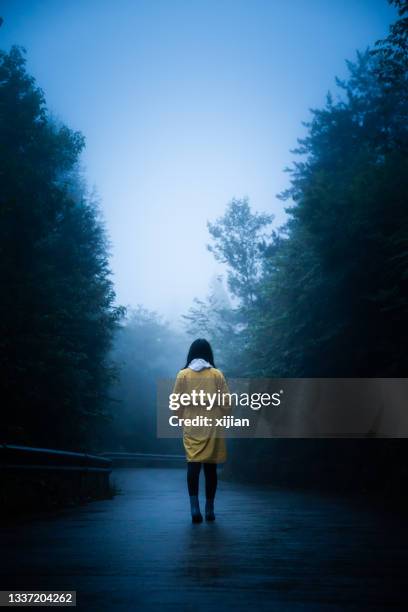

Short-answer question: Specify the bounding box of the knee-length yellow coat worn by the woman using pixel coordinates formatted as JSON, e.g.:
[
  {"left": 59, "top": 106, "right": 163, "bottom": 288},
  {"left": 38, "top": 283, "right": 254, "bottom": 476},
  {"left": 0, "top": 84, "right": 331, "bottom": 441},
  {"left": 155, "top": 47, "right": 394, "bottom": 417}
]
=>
[{"left": 173, "top": 368, "right": 230, "bottom": 463}]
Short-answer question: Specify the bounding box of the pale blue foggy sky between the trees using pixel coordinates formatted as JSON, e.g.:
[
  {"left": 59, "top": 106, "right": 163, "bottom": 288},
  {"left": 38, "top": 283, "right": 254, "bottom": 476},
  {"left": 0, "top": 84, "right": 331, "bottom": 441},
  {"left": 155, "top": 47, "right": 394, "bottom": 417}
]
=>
[{"left": 0, "top": 0, "right": 396, "bottom": 322}]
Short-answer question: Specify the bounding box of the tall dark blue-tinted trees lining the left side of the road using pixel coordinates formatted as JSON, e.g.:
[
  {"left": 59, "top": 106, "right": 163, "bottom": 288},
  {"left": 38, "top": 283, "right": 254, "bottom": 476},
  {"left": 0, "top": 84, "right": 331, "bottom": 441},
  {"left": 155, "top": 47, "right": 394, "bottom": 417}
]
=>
[{"left": 0, "top": 47, "right": 123, "bottom": 449}]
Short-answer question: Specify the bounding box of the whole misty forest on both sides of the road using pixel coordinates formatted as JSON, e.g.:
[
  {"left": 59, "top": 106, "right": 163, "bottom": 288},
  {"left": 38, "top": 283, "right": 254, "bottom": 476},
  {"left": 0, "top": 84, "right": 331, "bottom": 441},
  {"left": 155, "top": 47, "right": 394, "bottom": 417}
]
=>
[{"left": 0, "top": 0, "right": 408, "bottom": 486}]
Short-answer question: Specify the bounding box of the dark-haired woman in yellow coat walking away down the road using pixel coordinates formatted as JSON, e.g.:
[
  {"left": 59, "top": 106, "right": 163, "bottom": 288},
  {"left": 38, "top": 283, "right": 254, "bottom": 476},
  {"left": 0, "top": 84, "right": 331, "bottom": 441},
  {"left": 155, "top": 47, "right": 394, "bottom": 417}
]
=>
[{"left": 173, "top": 338, "right": 230, "bottom": 523}]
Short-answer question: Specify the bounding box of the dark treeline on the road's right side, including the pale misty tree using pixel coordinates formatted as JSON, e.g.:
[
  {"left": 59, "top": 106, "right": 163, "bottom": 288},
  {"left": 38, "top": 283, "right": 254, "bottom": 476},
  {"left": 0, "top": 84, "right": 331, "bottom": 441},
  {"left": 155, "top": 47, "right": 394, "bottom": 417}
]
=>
[{"left": 187, "top": 2, "right": 408, "bottom": 486}]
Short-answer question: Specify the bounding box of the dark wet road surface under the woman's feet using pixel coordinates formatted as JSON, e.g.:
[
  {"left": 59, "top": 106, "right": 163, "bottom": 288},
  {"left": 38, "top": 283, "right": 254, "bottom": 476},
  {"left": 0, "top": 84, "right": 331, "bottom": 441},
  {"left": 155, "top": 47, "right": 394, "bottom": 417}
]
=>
[{"left": 0, "top": 468, "right": 408, "bottom": 612}]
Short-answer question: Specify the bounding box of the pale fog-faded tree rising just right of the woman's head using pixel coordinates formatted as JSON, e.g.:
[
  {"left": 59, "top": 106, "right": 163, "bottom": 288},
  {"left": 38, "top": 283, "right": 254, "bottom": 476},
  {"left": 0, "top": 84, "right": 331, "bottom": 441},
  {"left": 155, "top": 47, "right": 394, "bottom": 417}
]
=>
[{"left": 184, "top": 198, "right": 273, "bottom": 376}]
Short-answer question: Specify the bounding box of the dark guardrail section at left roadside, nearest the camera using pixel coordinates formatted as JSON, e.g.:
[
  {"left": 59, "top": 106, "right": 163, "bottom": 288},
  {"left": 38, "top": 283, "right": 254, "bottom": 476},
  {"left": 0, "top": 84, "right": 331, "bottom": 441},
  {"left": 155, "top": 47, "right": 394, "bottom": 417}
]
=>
[{"left": 0, "top": 444, "right": 112, "bottom": 515}]
